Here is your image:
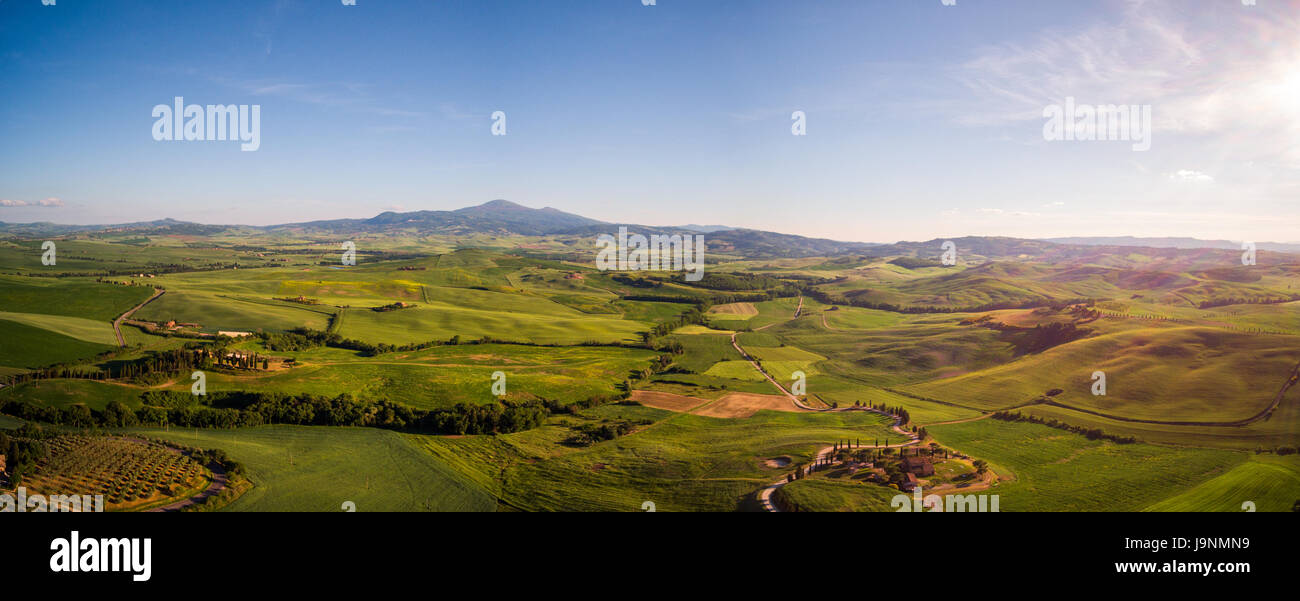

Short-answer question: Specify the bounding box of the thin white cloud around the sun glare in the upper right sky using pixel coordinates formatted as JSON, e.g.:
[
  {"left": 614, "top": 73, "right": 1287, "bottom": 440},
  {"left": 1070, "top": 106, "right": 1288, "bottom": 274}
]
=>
[{"left": 946, "top": 0, "right": 1300, "bottom": 167}]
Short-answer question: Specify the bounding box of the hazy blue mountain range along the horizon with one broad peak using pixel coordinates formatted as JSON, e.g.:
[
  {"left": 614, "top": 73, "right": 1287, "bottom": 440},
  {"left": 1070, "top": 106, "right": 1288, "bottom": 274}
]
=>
[{"left": 0, "top": 199, "right": 1300, "bottom": 262}]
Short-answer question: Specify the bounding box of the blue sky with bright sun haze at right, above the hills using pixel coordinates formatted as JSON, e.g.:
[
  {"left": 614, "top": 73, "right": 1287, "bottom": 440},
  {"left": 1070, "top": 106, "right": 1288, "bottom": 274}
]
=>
[{"left": 0, "top": 0, "right": 1300, "bottom": 242}]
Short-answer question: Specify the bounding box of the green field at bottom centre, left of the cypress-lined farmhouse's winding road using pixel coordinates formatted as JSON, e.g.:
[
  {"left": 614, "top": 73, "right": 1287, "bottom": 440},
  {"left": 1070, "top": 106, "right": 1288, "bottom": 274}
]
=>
[{"left": 424, "top": 406, "right": 897, "bottom": 511}]
